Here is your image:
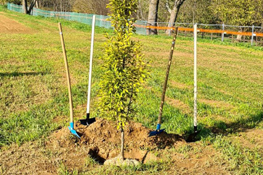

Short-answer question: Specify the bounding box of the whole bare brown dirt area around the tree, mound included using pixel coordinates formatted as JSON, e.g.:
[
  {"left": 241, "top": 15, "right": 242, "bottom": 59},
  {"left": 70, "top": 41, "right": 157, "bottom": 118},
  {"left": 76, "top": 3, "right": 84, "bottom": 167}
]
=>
[{"left": 0, "top": 119, "right": 232, "bottom": 174}]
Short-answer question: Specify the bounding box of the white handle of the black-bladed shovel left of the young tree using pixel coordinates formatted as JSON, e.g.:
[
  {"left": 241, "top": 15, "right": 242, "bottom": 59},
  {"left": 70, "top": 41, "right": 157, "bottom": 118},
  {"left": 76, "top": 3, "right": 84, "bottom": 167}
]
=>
[{"left": 87, "top": 15, "right": 96, "bottom": 114}]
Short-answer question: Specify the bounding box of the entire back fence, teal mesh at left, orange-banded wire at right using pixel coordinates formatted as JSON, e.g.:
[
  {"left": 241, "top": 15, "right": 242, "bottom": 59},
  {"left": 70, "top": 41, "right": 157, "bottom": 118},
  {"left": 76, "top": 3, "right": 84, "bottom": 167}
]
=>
[{"left": 7, "top": 3, "right": 263, "bottom": 45}]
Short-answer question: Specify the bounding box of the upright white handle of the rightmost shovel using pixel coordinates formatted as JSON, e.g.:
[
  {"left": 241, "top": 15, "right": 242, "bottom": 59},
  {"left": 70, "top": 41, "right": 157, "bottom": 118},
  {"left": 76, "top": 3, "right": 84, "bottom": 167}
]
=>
[{"left": 194, "top": 24, "right": 197, "bottom": 133}]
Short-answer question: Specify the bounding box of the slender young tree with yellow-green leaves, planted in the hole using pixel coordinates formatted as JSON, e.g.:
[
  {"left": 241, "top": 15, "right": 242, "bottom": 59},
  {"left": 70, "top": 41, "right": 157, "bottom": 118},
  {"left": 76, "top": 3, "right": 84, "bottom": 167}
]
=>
[{"left": 99, "top": 0, "right": 147, "bottom": 160}]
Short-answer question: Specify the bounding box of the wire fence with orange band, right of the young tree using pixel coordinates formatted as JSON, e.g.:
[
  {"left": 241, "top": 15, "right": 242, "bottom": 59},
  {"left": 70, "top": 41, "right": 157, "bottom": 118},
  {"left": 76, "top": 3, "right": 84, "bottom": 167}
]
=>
[{"left": 150, "top": 22, "right": 263, "bottom": 45}]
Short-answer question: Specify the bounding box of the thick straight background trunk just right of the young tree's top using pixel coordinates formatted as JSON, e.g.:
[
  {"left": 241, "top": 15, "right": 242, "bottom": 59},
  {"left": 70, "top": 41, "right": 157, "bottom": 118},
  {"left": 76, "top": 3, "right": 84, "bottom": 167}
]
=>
[{"left": 147, "top": 0, "right": 159, "bottom": 35}]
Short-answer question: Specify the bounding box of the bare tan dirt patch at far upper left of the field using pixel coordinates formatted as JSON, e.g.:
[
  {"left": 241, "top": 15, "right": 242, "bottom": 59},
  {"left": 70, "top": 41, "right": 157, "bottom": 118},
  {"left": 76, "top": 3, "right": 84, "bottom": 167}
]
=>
[{"left": 0, "top": 14, "right": 32, "bottom": 34}]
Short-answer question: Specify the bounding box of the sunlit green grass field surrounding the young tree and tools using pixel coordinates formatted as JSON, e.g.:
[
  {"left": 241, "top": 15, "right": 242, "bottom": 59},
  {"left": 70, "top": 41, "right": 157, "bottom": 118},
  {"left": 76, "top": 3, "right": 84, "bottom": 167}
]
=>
[{"left": 0, "top": 6, "right": 263, "bottom": 174}]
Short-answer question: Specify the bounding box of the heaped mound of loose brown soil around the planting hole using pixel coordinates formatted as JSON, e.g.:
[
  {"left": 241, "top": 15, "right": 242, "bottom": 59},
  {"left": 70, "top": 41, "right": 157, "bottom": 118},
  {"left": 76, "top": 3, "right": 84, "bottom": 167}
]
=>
[{"left": 48, "top": 119, "right": 185, "bottom": 163}]
